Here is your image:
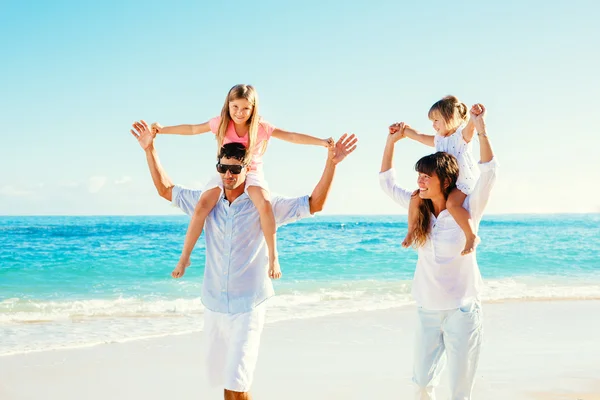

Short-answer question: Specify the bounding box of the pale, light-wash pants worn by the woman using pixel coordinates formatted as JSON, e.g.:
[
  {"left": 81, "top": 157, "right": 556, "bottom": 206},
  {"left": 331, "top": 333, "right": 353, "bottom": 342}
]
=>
[{"left": 413, "top": 301, "right": 483, "bottom": 400}]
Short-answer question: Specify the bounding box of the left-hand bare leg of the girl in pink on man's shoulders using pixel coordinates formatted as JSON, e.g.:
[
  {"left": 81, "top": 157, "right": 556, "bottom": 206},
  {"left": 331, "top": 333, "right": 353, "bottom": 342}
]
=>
[{"left": 171, "top": 187, "right": 221, "bottom": 278}]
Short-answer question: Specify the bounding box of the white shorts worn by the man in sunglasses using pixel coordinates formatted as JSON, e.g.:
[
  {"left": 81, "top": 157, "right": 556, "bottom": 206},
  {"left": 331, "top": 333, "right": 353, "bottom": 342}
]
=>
[{"left": 204, "top": 303, "right": 266, "bottom": 392}]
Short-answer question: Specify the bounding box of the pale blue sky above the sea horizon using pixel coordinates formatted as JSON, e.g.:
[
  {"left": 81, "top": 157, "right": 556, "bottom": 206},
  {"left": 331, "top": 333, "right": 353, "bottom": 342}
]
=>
[{"left": 0, "top": 0, "right": 600, "bottom": 215}]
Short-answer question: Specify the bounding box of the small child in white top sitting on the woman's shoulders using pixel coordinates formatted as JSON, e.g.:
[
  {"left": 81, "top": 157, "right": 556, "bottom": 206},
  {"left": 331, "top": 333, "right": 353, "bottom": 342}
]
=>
[{"left": 390, "top": 96, "right": 481, "bottom": 255}]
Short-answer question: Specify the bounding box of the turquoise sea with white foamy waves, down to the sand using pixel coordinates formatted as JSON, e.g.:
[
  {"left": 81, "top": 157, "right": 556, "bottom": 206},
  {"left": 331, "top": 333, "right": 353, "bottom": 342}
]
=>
[{"left": 0, "top": 214, "right": 600, "bottom": 355}]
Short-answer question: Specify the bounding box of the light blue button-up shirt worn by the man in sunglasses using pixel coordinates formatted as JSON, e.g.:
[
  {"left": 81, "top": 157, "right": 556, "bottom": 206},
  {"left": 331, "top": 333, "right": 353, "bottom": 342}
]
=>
[{"left": 172, "top": 186, "right": 311, "bottom": 314}]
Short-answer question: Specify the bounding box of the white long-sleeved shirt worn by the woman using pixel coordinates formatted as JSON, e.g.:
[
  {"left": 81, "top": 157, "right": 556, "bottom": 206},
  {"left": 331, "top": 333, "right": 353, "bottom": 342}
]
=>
[{"left": 379, "top": 158, "right": 498, "bottom": 310}]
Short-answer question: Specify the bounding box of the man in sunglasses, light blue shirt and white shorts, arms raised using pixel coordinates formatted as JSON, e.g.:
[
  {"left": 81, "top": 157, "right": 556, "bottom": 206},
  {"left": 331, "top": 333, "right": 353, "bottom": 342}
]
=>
[{"left": 131, "top": 121, "right": 357, "bottom": 400}]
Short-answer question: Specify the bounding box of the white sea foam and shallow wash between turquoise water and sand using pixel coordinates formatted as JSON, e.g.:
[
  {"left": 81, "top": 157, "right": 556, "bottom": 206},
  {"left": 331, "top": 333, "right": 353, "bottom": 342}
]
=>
[{"left": 0, "top": 276, "right": 600, "bottom": 355}]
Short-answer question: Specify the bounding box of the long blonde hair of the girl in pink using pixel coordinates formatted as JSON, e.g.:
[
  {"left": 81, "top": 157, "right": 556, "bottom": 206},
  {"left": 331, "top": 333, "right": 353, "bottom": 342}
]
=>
[{"left": 217, "top": 84, "right": 264, "bottom": 164}]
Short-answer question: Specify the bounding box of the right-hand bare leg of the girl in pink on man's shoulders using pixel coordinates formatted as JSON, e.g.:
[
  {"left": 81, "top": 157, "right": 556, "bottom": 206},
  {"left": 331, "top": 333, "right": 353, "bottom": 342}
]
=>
[{"left": 247, "top": 186, "right": 281, "bottom": 279}]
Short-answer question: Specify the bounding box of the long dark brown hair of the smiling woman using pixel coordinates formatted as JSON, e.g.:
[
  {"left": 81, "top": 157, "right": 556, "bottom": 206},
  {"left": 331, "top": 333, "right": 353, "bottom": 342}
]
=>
[{"left": 411, "top": 151, "right": 458, "bottom": 247}]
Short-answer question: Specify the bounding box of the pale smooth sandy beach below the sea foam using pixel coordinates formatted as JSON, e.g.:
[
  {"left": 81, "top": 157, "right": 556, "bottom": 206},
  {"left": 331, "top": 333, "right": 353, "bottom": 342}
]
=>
[{"left": 0, "top": 301, "right": 600, "bottom": 400}]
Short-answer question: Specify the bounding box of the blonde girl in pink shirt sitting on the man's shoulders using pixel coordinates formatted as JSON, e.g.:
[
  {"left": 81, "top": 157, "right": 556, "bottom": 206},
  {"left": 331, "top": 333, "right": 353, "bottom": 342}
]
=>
[{"left": 152, "top": 85, "right": 333, "bottom": 279}]
